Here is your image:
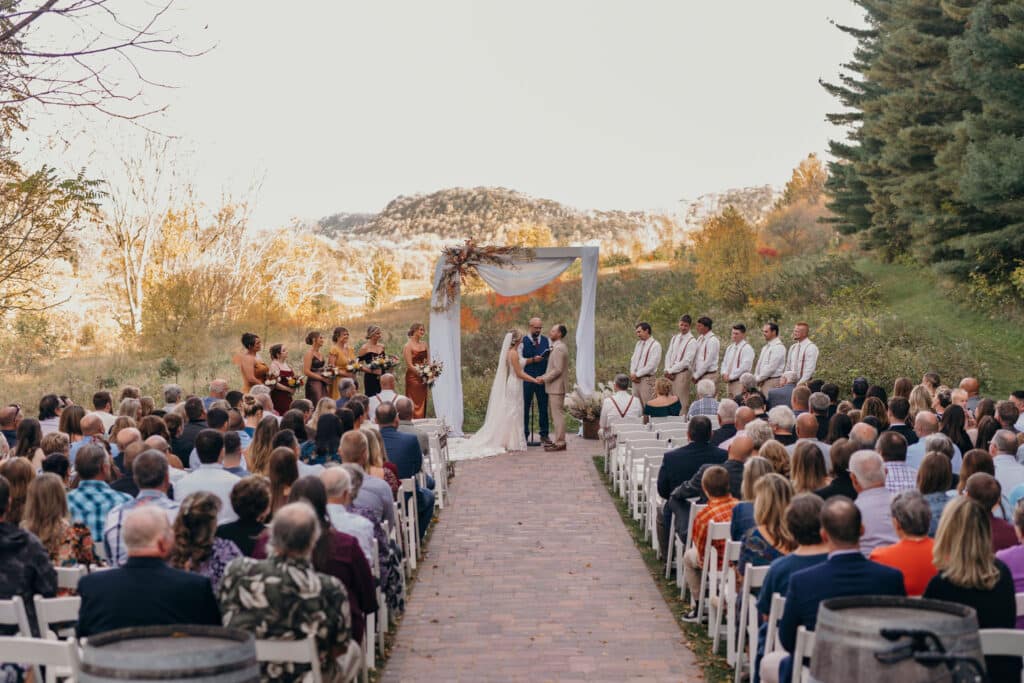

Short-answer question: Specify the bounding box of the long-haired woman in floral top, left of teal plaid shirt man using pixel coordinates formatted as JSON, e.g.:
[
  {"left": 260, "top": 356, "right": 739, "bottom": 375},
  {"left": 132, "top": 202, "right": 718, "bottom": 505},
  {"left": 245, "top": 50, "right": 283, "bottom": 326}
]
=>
[{"left": 22, "top": 472, "right": 99, "bottom": 567}]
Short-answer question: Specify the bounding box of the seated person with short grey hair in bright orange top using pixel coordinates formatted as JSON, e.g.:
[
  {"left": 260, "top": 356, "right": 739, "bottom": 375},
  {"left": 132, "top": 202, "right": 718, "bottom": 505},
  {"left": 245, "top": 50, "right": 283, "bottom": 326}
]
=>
[{"left": 868, "top": 489, "right": 936, "bottom": 598}]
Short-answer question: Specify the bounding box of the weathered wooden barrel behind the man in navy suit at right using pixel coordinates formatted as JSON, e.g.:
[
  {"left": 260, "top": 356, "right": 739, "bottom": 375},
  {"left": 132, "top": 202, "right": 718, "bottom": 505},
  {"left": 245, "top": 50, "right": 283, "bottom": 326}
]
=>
[{"left": 811, "top": 596, "right": 983, "bottom": 683}]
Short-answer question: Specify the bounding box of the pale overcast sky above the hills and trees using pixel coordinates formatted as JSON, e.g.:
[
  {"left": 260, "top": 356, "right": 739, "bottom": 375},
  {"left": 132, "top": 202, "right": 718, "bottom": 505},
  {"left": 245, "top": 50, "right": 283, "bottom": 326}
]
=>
[{"left": 19, "top": 0, "right": 859, "bottom": 227}]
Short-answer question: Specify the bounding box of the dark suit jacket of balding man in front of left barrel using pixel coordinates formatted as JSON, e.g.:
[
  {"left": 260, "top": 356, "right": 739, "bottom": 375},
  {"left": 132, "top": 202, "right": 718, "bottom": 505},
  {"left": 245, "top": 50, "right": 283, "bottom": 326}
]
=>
[{"left": 77, "top": 557, "right": 220, "bottom": 638}]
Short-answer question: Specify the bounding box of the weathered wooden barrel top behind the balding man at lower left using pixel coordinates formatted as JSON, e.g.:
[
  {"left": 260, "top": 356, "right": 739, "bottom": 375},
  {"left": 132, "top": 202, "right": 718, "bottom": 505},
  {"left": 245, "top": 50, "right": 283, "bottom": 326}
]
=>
[{"left": 78, "top": 625, "right": 259, "bottom": 683}]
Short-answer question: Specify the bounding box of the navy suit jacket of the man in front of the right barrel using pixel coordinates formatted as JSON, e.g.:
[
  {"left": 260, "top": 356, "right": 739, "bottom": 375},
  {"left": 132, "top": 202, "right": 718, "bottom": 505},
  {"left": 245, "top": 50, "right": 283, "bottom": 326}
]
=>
[{"left": 778, "top": 551, "right": 906, "bottom": 681}]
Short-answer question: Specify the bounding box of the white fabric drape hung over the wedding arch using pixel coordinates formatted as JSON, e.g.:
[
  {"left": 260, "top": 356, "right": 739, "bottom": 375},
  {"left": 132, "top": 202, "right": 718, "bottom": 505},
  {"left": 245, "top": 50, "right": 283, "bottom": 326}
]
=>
[{"left": 430, "top": 247, "right": 599, "bottom": 434}]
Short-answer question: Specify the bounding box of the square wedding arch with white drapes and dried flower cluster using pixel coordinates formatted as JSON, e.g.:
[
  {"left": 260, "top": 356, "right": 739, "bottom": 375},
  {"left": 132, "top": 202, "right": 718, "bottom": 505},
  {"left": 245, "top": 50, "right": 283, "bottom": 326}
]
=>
[{"left": 430, "top": 242, "right": 599, "bottom": 434}]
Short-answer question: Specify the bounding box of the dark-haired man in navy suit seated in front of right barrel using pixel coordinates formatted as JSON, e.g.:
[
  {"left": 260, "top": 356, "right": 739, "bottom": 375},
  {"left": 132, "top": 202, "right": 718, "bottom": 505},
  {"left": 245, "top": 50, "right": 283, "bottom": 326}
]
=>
[{"left": 761, "top": 496, "right": 906, "bottom": 683}]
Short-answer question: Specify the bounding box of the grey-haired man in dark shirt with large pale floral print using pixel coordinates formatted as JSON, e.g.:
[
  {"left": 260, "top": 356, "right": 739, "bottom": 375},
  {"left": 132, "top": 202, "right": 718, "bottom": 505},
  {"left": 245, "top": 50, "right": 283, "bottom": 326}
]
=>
[{"left": 218, "top": 503, "right": 362, "bottom": 683}]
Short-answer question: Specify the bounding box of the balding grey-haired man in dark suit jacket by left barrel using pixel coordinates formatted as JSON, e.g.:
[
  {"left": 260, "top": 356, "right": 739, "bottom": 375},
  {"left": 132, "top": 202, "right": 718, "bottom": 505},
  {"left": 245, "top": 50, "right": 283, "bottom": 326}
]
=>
[{"left": 77, "top": 505, "right": 220, "bottom": 637}]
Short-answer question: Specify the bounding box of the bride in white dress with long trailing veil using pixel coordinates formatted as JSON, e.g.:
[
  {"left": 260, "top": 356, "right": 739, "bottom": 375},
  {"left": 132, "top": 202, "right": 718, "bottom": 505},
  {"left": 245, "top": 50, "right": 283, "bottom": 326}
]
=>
[{"left": 450, "top": 330, "right": 540, "bottom": 460}]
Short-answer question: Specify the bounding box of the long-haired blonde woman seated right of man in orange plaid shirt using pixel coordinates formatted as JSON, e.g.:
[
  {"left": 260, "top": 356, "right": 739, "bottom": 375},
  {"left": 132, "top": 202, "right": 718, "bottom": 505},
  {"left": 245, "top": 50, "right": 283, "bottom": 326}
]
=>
[{"left": 738, "top": 472, "right": 797, "bottom": 575}]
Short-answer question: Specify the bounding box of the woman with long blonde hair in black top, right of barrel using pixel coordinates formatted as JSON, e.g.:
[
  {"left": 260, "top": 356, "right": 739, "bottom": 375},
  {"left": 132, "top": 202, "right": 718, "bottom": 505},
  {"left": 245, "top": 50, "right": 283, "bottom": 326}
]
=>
[{"left": 924, "top": 497, "right": 1021, "bottom": 681}]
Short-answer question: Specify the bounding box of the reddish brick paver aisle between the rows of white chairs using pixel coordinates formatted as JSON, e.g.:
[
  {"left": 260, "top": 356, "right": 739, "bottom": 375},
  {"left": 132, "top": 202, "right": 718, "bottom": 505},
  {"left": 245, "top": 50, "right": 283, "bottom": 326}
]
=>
[{"left": 383, "top": 439, "right": 700, "bottom": 683}]
